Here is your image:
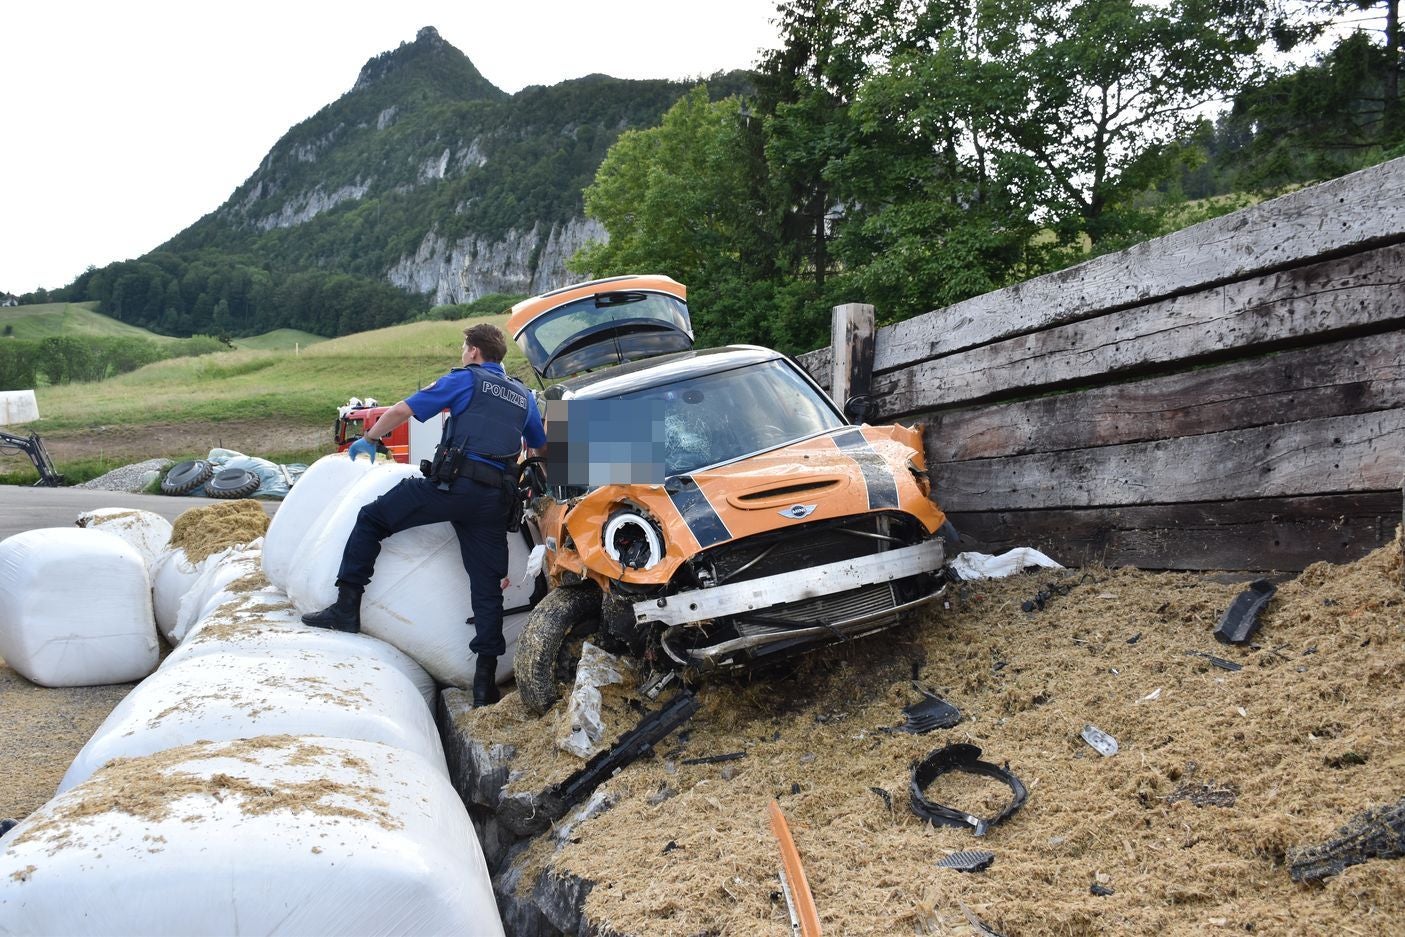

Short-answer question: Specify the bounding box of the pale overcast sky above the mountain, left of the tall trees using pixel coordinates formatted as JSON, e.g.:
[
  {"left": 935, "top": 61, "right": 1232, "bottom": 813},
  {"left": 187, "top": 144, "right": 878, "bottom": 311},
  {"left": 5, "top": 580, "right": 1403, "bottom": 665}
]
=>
[{"left": 0, "top": 0, "right": 776, "bottom": 294}]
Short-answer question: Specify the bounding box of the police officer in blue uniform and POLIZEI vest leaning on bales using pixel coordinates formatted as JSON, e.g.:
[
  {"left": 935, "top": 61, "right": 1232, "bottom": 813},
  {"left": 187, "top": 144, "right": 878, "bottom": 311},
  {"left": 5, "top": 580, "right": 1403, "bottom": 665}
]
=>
[{"left": 302, "top": 323, "right": 547, "bottom": 707}]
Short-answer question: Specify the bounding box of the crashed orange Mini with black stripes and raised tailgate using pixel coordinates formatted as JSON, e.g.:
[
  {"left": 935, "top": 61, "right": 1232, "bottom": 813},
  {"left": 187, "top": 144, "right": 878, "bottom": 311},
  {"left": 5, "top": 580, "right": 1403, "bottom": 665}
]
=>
[{"left": 507, "top": 275, "right": 950, "bottom": 712}]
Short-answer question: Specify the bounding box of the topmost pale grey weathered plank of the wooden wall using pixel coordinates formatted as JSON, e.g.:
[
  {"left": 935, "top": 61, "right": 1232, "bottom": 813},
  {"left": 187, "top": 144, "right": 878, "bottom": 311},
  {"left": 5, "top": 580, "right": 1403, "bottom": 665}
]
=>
[{"left": 875, "top": 157, "right": 1405, "bottom": 371}]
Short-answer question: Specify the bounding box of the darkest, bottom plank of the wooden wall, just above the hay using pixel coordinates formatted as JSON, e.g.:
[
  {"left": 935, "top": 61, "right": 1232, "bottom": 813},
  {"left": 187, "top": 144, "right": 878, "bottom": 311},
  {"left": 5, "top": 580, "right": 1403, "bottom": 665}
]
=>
[{"left": 948, "top": 489, "right": 1401, "bottom": 570}]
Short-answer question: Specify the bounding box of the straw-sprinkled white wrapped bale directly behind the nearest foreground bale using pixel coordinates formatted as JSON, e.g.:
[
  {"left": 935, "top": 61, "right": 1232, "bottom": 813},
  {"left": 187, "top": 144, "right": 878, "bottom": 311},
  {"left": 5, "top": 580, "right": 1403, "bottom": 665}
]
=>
[{"left": 59, "top": 648, "right": 448, "bottom": 794}]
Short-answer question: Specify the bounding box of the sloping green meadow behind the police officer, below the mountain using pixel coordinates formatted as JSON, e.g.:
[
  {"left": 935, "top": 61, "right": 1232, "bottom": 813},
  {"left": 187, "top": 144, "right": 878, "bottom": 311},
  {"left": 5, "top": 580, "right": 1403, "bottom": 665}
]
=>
[{"left": 27, "top": 316, "right": 530, "bottom": 434}]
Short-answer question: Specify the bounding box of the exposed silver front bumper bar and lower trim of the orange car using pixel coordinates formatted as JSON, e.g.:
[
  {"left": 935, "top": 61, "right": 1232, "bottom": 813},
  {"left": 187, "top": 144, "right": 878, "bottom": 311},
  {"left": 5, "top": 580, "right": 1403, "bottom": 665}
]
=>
[{"left": 634, "top": 539, "right": 946, "bottom": 664}]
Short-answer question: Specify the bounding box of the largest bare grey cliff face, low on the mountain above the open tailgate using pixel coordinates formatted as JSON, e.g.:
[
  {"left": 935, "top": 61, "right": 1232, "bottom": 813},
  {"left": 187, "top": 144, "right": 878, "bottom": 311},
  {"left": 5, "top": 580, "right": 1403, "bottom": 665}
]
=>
[{"left": 386, "top": 218, "right": 607, "bottom": 303}]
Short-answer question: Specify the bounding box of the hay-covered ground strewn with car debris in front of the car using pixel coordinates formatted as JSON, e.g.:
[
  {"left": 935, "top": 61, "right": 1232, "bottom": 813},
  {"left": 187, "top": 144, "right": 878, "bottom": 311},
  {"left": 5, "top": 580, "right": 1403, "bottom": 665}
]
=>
[{"left": 461, "top": 537, "right": 1405, "bottom": 937}]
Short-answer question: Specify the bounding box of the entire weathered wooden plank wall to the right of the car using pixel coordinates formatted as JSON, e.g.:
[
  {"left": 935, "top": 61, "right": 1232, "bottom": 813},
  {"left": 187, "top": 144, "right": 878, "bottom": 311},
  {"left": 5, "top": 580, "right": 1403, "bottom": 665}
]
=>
[{"left": 801, "top": 159, "right": 1405, "bottom": 570}]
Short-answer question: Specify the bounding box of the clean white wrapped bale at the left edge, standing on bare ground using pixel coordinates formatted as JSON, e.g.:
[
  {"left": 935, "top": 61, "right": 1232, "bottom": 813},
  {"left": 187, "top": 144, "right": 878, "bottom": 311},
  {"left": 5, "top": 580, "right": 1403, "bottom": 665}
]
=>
[{"left": 0, "top": 527, "right": 157, "bottom": 687}]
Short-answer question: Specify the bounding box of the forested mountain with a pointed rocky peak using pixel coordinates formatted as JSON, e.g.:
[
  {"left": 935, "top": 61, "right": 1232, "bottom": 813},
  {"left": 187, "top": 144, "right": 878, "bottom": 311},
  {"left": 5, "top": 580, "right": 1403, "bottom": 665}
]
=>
[{"left": 22, "top": 28, "right": 746, "bottom": 344}]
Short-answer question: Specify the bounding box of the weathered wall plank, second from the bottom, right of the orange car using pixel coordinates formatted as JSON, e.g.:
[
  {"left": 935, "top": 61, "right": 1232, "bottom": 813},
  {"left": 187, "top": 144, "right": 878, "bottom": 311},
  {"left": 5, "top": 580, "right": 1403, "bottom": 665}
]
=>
[{"left": 932, "top": 409, "right": 1405, "bottom": 511}]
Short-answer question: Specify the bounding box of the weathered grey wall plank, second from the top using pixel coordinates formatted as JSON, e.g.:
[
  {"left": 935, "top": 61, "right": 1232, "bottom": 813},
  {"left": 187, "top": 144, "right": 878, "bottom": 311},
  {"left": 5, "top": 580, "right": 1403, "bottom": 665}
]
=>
[{"left": 874, "top": 246, "right": 1405, "bottom": 414}]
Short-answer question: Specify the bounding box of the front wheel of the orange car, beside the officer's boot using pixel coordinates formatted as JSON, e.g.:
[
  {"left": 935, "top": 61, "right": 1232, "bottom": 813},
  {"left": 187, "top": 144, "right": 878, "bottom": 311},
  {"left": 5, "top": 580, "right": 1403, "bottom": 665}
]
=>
[{"left": 513, "top": 584, "right": 600, "bottom": 715}]
